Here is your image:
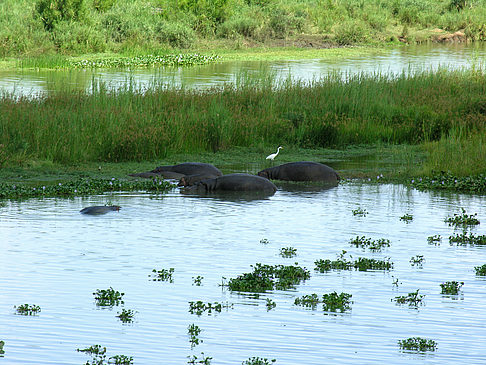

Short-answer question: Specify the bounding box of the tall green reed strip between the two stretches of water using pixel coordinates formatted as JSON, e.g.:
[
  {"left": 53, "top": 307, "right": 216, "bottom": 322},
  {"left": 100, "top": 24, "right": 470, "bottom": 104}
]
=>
[{"left": 0, "top": 69, "right": 486, "bottom": 189}]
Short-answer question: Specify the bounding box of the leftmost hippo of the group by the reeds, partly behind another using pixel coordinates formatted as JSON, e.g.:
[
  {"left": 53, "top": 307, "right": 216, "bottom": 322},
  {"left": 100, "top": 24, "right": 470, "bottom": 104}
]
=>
[{"left": 130, "top": 162, "right": 223, "bottom": 179}]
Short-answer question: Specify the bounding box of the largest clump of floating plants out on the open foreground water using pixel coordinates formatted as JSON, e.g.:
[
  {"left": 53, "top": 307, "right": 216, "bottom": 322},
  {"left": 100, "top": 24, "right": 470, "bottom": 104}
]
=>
[{"left": 227, "top": 263, "right": 310, "bottom": 292}]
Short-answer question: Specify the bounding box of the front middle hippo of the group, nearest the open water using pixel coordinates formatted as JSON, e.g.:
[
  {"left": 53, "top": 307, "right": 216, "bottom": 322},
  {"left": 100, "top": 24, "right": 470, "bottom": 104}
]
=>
[{"left": 185, "top": 173, "right": 277, "bottom": 194}]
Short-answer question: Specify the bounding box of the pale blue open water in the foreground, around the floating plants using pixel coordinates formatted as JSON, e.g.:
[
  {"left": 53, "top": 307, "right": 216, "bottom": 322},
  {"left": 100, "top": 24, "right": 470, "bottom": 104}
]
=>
[{"left": 0, "top": 184, "right": 486, "bottom": 365}]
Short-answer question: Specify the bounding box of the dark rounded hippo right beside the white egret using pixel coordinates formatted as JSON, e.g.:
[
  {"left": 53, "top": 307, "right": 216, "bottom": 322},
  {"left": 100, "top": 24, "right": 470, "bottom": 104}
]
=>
[{"left": 258, "top": 161, "right": 341, "bottom": 184}]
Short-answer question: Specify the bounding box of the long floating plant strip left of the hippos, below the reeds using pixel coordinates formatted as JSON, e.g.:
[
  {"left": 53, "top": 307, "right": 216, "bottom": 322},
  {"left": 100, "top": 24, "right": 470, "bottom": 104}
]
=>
[{"left": 0, "top": 178, "right": 173, "bottom": 199}]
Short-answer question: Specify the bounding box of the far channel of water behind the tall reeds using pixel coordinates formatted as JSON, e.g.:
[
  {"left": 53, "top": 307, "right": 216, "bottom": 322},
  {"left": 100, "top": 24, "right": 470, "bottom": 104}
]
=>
[{"left": 0, "top": 43, "right": 486, "bottom": 96}]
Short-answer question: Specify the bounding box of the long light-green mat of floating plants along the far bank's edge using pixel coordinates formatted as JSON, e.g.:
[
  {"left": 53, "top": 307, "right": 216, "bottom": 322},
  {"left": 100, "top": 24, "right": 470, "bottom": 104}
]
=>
[{"left": 70, "top": 53, "right": 221, "bottom": 69}]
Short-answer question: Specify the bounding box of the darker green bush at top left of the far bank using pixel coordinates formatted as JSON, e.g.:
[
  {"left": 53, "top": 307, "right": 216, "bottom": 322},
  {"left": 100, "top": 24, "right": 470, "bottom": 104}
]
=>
[{"left": 35, "top": 0, "right": 86, "bottom": 31}]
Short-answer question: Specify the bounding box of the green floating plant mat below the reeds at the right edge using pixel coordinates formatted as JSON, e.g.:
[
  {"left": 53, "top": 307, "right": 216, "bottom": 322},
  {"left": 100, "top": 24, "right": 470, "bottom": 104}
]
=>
[{"left": 410, "top": 174, "right": 486, "bottom": 193}]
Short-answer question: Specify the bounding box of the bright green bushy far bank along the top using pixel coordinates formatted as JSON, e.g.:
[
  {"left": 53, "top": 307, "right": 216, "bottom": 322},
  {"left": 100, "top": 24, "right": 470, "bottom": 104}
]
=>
[{"left": 0, "top": 0, "right": 486, "bottom": 57}]
